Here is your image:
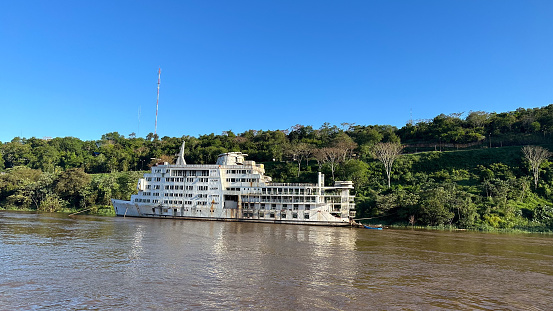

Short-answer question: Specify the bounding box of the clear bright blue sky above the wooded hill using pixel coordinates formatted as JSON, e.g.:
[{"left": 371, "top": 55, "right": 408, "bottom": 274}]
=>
[{"left": 0, "top": 0, "right": 553, "bottom": 142}]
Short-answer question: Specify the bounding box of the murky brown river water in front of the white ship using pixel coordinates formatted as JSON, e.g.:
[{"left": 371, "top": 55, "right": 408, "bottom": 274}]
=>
[{"left": 0, "top": 211, "right": 553, "bottom": 310}]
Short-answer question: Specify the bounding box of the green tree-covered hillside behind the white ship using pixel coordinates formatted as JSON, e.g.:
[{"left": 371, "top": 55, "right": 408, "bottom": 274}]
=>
[{"left": 0, "top": 105, "right": 553, "bottom": 232}]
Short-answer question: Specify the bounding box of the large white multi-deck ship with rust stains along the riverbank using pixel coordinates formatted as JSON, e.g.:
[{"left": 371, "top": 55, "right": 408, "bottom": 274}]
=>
[{"left": 111, "top": 143, "right": 355, "bottom": 226}]
